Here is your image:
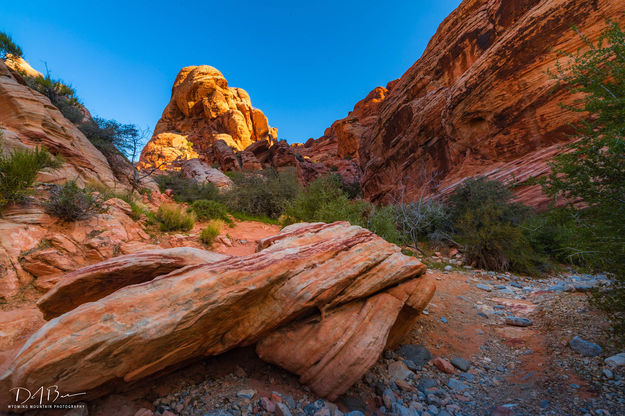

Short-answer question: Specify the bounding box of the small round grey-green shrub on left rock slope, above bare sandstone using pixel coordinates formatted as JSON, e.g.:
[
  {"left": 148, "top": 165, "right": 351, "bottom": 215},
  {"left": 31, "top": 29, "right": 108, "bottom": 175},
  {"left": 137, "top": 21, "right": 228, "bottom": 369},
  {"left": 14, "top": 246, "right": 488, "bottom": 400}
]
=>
[{"left": 44, "top": 181, "right": 104, "bottom": 222}]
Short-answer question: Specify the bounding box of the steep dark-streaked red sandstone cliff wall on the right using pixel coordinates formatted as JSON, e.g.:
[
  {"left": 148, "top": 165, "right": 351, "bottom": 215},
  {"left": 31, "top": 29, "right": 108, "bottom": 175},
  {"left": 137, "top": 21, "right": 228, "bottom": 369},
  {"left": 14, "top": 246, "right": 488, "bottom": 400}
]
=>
[{"left": 332, "top": 0, "right": 625, "bottom": 207}]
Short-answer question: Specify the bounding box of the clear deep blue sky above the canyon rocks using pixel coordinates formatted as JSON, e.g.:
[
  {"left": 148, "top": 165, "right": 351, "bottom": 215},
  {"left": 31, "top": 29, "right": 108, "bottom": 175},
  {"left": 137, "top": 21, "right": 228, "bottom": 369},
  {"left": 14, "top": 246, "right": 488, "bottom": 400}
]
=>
[{"left": 0, "top": 0, "right": 460, "bottom": 142}]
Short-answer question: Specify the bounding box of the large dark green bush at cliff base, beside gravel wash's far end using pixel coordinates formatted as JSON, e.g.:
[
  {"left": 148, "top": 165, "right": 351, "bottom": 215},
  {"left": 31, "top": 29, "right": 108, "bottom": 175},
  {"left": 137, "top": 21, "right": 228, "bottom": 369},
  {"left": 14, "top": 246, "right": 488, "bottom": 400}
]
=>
[{"left": 448, "top": 178, "right": 537, "bottom": 273}]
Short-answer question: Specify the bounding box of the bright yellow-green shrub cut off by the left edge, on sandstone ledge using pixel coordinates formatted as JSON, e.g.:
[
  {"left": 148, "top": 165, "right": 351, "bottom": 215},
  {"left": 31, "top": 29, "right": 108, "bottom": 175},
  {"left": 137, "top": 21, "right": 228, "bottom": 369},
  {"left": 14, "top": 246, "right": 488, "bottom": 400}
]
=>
[{"left": 0, "top": 144, "right": 61, "bottom": 208}]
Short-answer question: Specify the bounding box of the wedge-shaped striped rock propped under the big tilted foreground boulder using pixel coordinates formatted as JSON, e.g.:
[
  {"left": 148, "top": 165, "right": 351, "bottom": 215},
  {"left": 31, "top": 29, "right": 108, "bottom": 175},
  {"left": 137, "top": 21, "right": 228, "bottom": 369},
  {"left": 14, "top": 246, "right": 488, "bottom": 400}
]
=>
[{"left": 256, "top": 276, "right": 436, "bottom": 400}]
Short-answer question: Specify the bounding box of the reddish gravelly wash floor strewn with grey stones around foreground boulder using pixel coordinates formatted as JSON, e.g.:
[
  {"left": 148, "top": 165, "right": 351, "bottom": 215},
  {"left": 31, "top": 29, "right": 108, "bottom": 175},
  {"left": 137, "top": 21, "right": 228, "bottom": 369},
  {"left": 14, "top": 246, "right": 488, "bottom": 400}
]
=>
[{"left": 58, "top": 266, "right": 625, "bottom": 416}]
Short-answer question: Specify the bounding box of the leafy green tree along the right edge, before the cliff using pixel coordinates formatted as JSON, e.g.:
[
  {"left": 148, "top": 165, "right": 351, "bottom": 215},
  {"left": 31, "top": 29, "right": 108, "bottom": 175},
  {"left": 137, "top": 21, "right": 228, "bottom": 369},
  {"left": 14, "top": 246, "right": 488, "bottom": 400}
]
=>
[{"left": 543, "top": 22, "right": 625, "bottom": 341}]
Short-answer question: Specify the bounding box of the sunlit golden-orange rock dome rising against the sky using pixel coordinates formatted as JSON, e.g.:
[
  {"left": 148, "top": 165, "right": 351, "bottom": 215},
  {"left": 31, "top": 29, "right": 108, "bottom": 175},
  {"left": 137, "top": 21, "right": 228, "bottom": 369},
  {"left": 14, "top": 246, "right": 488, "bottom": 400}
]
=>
[{"left": 139, "top": 65, "right": 278, "bottom": 169}]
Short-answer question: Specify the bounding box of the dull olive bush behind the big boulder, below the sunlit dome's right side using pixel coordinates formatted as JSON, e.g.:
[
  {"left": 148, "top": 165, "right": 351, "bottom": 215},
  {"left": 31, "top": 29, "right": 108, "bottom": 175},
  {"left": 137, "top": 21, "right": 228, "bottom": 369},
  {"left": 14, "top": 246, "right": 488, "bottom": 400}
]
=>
[{"left": 224, "top": 168, "right": 300, "bottom": 219}]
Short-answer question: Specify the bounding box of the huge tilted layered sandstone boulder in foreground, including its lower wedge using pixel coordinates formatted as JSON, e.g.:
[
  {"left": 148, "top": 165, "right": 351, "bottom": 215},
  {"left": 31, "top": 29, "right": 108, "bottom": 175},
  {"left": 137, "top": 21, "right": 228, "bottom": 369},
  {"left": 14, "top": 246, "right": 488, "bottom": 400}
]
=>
[{"left": 0, "top": 223, "right": 434, "bottom": 400}]
